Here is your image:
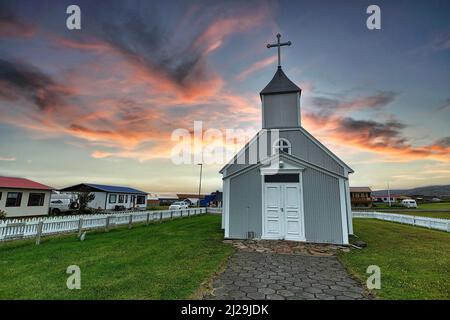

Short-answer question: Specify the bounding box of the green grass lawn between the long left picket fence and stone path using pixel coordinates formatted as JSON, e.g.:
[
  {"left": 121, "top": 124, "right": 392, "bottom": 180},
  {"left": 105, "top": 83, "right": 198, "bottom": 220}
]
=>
[{"left": 0, "top": 215, "right": 233, "bottom": 299}]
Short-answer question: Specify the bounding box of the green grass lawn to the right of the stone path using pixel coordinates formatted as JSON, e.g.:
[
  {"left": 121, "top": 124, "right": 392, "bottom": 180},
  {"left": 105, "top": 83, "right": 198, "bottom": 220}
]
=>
[{"left": 339, "top": 219, "right": 450, "bottom": 299}]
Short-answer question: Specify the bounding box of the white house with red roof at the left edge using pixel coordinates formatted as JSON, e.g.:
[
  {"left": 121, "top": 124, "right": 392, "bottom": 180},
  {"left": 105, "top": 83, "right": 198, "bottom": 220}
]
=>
[{"left": 0, "top": 176, "right": 52, "bottom": 218}]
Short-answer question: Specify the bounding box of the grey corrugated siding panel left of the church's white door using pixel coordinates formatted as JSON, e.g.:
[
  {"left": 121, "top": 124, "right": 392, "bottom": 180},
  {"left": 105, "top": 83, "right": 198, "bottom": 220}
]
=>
[{"left": 229, "top": 168, "right": 262, "bottom": 239}]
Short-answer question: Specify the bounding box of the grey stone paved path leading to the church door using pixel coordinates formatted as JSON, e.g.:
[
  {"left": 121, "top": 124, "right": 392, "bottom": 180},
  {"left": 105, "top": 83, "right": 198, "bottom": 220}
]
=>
[{"left": 204, "top": 251, "right": 368, "bottom": 300}]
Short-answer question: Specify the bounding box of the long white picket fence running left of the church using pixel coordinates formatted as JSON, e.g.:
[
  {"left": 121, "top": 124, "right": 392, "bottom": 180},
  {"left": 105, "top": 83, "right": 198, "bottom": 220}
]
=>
[{"left": 0, "top": 208, "right": 206, "bottom": 243}]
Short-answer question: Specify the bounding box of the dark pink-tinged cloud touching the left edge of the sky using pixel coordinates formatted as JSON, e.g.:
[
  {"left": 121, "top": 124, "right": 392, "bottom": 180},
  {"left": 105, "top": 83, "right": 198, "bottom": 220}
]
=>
[{"left": 0, "top": 59, "right": 68, "bottom": 110}]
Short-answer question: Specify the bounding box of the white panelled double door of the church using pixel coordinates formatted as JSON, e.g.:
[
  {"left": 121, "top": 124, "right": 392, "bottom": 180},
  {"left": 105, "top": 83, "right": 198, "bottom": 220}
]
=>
[{"left": 263, "top": 183, "right": 305, "bottom": 241}]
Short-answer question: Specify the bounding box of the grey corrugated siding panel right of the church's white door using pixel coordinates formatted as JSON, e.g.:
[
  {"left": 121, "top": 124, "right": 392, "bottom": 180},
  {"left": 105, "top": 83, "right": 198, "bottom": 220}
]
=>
[{"left": 303, "top": 168, "right": 342, "bottom": 243}]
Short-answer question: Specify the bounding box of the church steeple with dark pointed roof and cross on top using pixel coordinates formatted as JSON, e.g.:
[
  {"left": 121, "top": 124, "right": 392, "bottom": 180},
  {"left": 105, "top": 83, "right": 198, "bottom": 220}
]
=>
[{"left": 260, "top": 34, "right": 302, "bottom": 129}]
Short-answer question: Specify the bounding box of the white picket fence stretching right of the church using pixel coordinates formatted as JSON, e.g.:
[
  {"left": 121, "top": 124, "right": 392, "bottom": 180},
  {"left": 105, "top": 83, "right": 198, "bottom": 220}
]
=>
[{"left": 352, "top": 211, "right": 450, "bottom": 232}]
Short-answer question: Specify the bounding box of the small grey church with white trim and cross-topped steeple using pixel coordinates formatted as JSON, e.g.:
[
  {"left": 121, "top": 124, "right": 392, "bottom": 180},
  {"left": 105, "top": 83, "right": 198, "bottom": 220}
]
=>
[{"left": 220, "top": 34, "right": 353, "bottom": 244}]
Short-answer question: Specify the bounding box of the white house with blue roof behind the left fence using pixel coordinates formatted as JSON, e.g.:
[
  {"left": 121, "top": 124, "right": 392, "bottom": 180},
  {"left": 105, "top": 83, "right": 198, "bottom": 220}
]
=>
[{"left": 60, "top": 183, "right": 147, "bottom": 210}]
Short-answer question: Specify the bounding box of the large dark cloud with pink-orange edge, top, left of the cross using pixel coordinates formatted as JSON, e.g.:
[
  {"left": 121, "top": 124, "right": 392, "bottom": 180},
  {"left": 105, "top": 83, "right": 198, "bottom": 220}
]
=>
[{"left": 59, "top": 2, "right": 268, "bottom": 93}]
